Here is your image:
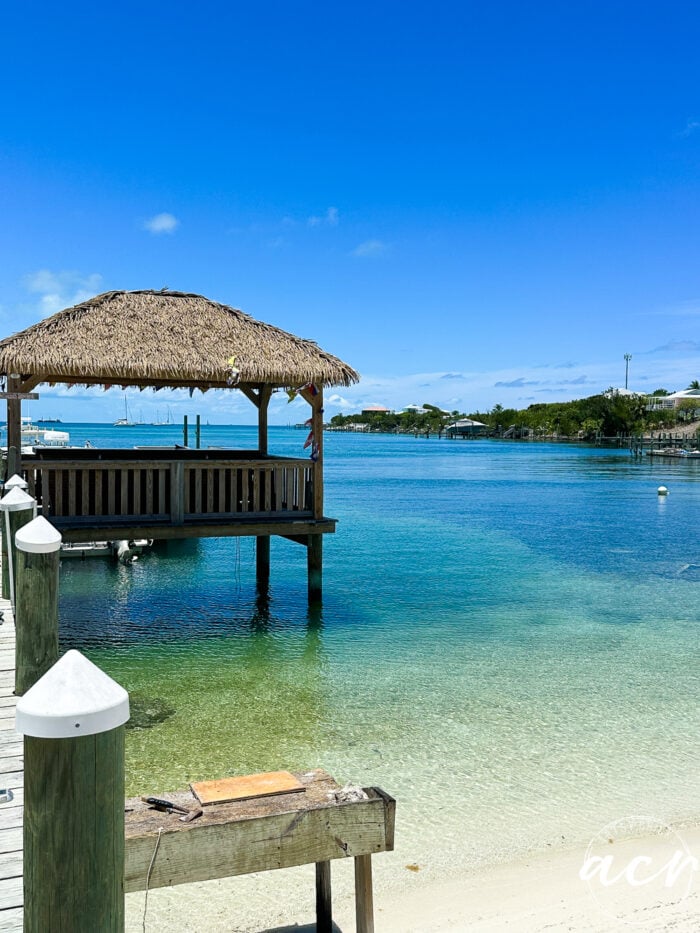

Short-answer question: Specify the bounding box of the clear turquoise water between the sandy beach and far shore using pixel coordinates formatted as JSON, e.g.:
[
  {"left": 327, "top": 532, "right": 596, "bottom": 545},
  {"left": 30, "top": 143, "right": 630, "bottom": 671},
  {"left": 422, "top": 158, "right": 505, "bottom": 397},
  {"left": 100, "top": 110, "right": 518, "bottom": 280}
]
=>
[{"left": 56, "top": 425, "right": 700, "bottom": 872}]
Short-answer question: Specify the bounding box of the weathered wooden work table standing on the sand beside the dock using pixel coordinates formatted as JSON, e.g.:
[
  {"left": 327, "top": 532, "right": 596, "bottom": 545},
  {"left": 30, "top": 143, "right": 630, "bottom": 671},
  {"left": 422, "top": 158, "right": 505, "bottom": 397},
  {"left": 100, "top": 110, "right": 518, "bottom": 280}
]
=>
[{"left": 125, "top": 770, "right": 396, "bottom": 933}]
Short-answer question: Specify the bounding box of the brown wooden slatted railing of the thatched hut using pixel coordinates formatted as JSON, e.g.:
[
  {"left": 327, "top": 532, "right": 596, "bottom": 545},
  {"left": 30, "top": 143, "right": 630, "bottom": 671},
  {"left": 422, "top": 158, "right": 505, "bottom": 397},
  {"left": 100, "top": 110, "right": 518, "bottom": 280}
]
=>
[{"left": 22, "top": 458, "right": 320, "bottom": 525}]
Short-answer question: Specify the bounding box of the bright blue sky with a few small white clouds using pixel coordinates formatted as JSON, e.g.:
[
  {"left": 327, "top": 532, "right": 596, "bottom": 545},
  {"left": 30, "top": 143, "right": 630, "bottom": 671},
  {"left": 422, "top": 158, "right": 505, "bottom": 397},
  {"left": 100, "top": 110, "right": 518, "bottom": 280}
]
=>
[{"left": 0, "top": 0, "right": 700, "bottom": 423}]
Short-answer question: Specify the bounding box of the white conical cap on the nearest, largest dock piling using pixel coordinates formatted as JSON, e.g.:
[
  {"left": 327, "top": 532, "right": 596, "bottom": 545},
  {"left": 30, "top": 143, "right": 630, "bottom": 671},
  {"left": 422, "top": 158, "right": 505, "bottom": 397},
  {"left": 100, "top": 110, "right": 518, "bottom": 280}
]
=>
[{"left": 15, "top": 651, "right": 129, "bottom": 739}]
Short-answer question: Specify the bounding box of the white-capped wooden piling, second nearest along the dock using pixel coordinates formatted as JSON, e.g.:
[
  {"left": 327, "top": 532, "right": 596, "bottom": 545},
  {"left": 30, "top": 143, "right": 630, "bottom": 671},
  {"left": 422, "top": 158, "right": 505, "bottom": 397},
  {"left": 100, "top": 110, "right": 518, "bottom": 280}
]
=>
[{"left": 15, "top": 515, "right": 61, "bottom": 696}]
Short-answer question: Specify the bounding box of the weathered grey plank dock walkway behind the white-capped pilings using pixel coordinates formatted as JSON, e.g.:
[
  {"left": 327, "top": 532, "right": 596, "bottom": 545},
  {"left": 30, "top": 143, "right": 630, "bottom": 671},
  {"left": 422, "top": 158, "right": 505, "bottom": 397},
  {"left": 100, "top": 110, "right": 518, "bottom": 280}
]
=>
[{"left": 0, "top": 580, "right": 24, "bottom": 933}]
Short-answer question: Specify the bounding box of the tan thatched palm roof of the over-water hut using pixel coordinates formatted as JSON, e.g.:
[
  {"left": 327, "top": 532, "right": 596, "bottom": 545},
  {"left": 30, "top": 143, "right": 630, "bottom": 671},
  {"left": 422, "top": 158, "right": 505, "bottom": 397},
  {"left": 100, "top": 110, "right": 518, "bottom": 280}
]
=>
[{"left": 0, "top": 290, "right": 359, "bottom": 388}]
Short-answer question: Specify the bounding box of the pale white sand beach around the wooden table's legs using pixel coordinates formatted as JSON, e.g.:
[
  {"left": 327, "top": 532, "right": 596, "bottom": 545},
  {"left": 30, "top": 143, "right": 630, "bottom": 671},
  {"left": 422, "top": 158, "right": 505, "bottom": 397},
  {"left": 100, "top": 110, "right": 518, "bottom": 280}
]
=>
[{"left": 127, "top": 826, "right": 700, "bottom": 933}]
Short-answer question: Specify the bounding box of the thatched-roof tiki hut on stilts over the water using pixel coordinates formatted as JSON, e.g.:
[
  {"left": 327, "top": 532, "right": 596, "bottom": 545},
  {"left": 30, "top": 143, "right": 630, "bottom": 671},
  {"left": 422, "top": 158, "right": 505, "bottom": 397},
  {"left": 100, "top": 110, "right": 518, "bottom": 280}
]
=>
[{"left": 0, "top": 289, "right": 359, "bottom": 593}]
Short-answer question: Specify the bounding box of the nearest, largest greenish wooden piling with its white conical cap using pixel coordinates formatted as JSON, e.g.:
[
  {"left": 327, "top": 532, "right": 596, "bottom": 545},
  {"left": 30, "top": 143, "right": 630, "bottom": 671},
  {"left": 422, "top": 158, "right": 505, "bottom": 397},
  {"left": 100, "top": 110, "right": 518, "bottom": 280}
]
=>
[{"left": 16, "top": 651, "right": 129, "bottom": 933}]
